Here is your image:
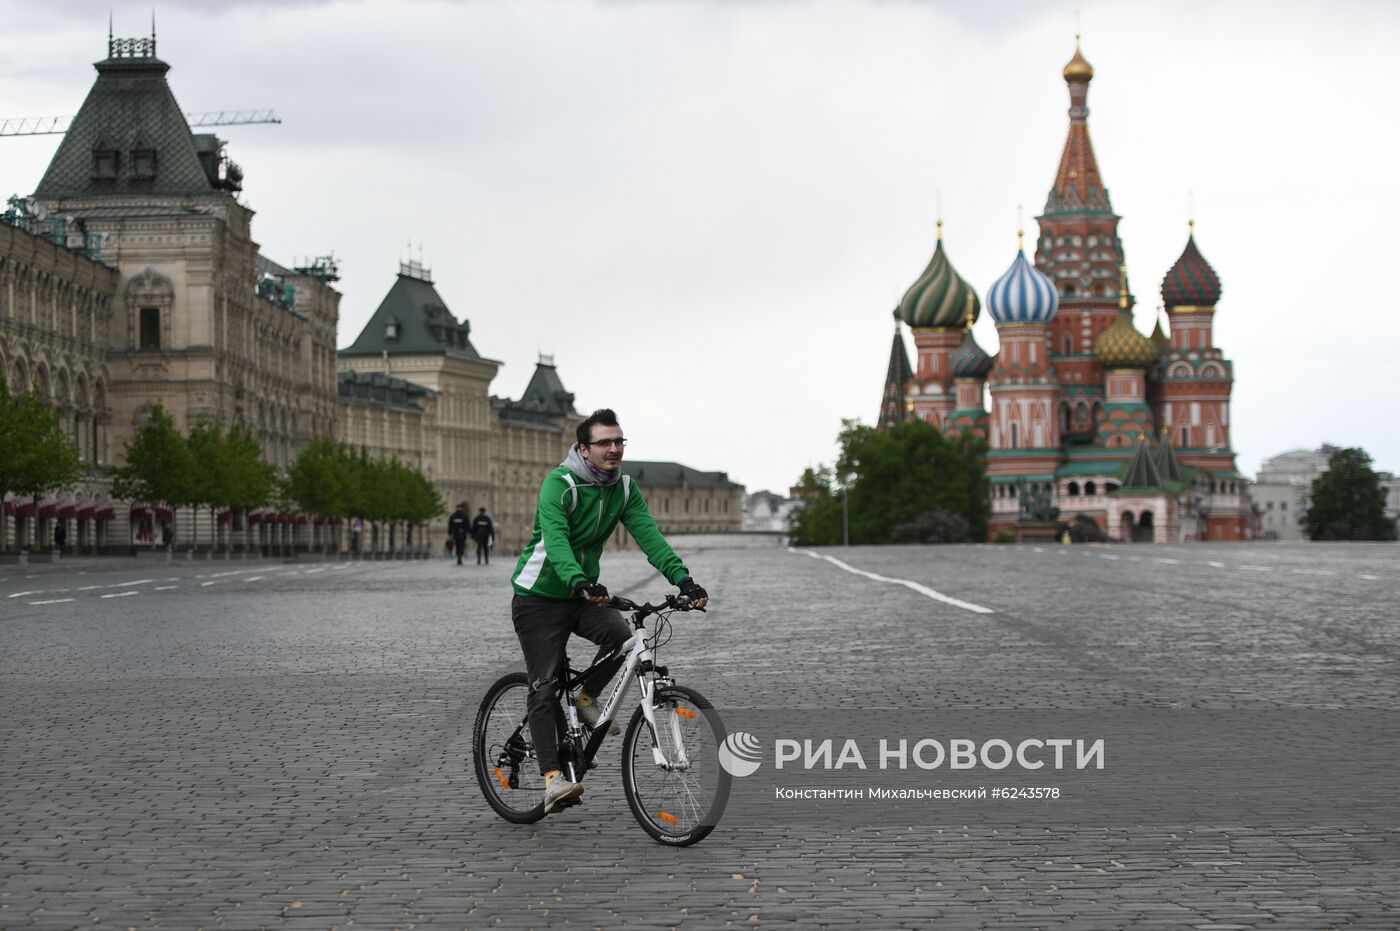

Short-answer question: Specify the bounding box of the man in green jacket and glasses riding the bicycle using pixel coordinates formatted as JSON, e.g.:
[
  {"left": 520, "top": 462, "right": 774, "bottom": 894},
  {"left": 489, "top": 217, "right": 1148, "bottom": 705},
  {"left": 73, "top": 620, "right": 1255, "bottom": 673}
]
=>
[{"left": 511, "top": 409, "right": 708, "bottom": 812}]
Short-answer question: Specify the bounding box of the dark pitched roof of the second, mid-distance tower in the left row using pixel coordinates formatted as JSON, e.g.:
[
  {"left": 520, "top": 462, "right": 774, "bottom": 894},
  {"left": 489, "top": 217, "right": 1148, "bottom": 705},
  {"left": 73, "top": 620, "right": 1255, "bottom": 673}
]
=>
[{"left": 340, "top": 272, "right": 482, "bottom": 358}]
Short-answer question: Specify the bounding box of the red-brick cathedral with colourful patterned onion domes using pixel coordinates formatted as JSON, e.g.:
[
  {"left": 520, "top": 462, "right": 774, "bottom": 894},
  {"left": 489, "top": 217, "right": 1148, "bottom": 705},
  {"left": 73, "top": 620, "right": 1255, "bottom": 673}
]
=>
[{"left": 879, "top": 42, "right": 1249, "bottom": 543}]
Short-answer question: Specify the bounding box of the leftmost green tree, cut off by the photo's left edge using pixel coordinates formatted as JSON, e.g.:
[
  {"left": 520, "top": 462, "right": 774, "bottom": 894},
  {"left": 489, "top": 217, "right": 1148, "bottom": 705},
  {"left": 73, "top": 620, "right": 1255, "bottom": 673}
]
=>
[{"left": 0, "top": 377, "right": 87, "bottom": 546}]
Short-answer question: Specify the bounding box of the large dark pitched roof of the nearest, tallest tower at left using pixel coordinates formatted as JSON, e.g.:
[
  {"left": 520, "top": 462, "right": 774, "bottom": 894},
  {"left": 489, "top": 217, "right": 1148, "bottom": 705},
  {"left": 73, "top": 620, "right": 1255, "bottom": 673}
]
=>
[{"left": 35, "top": 43, "right": 221, "bottom": 197}]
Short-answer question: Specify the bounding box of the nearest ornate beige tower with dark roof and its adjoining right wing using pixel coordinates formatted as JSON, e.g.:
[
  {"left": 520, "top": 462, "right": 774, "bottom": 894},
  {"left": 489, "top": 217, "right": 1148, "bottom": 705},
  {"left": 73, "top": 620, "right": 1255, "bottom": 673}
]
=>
[{"left": 32, "top": 31, "right": 340, "bottom": 466}]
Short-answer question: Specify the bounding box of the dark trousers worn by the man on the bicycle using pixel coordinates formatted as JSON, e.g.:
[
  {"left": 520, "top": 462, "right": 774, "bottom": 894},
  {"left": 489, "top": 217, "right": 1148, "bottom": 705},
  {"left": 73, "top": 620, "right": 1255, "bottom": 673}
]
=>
[{"left": 511, "top": 595, "right": 631, "bottom": 773}]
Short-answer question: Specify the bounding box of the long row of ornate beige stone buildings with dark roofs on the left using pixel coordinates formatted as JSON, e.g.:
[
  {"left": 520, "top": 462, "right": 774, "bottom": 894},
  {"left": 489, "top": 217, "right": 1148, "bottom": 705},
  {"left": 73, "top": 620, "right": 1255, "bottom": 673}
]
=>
[{"left": 0, "top": 35, "right": 742, "bottom": 552}]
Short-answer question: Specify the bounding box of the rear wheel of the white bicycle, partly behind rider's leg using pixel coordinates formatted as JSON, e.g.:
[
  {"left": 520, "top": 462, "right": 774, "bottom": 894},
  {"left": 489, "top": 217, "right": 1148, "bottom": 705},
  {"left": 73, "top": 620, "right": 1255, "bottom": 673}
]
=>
[{"left": 472, "top": 672, "right": 545, "bottom": 825}]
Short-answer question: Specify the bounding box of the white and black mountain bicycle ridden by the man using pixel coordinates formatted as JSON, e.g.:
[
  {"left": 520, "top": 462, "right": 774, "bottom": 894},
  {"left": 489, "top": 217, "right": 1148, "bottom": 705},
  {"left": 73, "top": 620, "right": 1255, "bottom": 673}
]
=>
[{"left": 472, "top": 595, "right": 731, "bottom": 847}]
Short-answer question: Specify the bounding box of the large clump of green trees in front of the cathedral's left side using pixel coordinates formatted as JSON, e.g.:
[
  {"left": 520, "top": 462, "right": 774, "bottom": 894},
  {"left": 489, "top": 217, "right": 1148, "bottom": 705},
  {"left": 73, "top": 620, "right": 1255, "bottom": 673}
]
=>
[{"left": 792, "top": 420, "right": 990, "bottom": 545}]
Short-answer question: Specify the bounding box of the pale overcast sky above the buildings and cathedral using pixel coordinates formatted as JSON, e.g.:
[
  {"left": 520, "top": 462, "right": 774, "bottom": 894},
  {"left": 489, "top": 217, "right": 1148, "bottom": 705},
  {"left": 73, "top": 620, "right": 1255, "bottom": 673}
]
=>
[{"left": 0, "top": 0, "right": 1400, "bottom": 491}]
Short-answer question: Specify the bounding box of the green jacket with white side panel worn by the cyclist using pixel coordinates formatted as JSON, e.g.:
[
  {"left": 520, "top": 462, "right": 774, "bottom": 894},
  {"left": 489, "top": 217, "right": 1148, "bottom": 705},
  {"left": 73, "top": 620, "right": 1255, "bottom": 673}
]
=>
[{"left": 511, "top": 447, "right": 690, "bottom": 601}]
